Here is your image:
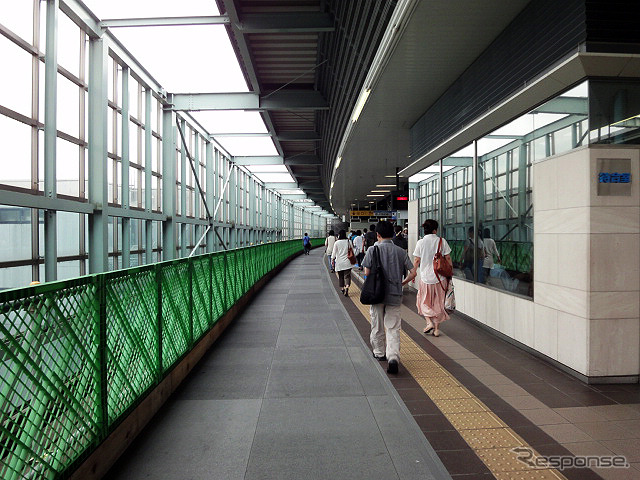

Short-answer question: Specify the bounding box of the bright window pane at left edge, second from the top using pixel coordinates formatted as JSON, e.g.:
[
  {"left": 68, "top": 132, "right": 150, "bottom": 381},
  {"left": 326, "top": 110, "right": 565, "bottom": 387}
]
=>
[{"left": 0, "top": 35, "right": 32, "bottom": 117}]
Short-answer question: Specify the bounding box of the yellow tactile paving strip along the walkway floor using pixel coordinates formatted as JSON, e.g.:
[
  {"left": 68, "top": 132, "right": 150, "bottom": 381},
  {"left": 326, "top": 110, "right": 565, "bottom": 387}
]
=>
[{"left": 349, "top": 284, "right": 566, "bottom": 480}]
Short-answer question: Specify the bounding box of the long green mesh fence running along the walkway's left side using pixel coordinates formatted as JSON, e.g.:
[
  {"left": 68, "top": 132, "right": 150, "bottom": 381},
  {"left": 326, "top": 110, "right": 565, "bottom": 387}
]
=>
[{"left": 0, "top": 239, "right": 312, "bottom": 480}]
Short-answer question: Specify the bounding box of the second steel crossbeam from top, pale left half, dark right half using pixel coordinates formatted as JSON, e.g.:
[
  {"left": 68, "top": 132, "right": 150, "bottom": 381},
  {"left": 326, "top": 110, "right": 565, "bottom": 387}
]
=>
[{"left": 170, "top": 90, "right": 329, "bottom": 111}]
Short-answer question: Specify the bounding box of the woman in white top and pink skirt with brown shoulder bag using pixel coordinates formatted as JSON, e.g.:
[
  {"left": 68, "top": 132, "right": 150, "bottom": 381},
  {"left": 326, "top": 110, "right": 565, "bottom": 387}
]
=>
[{"left": 413, "top": 219, "right": 453, "bottom": 337}]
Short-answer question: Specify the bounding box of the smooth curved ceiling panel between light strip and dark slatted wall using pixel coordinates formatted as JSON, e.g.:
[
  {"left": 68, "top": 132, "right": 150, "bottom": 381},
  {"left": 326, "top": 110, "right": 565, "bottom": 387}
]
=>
[{"left": 331, "top": 0, "right": 528, "bottom": 214}]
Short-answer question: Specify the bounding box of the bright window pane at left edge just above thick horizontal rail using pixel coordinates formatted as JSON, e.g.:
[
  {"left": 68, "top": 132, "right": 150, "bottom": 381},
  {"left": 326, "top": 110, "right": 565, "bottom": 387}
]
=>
[{"left": 0, "top": 114, "right": 31, "bottom": 189}]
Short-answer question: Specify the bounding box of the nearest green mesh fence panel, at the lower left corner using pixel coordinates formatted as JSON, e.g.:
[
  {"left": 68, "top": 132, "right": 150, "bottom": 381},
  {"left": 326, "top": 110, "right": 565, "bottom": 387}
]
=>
[{"left": 0, "top": 279, "right": 102, "bottom": 479}]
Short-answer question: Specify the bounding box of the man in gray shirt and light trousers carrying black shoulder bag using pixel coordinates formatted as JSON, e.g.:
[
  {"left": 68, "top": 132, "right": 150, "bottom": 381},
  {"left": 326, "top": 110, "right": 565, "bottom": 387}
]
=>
[{"left": 362, "top": 220, "right": 416, "bottom": 373}]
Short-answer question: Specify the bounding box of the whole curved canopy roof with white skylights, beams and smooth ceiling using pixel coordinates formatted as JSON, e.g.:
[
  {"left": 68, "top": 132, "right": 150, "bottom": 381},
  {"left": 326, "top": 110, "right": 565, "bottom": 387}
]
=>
[{"left": 82, "top": 0, "right": 528, "bottom": 214}]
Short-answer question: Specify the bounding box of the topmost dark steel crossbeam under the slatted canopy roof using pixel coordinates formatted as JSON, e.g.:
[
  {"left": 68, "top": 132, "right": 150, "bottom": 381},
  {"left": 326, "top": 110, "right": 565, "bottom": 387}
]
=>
[{"left": 236, "top": 12, "right": 335, "bottom": 33}]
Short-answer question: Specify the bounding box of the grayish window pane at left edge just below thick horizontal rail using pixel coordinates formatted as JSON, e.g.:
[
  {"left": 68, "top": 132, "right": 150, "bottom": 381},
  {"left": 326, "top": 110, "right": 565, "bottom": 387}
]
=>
[{"left": 0, "top": 205, "right": 31, "bottom": 260}]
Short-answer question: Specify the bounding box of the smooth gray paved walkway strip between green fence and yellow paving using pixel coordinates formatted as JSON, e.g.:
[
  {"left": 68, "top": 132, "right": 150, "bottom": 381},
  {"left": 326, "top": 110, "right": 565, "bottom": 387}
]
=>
[{"left": 108, "top": 248, "right": 451, "bottom": 480}]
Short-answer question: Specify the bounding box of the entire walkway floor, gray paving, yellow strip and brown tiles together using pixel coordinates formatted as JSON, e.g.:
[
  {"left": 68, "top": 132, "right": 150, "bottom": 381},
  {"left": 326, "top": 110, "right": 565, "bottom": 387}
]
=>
[{"left": 108, "top": 249, "right": 640, "bottom": 480}]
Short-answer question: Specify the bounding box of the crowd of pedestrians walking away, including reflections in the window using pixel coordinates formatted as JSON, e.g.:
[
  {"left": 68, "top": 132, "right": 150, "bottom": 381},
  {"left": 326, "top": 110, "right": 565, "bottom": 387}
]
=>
[{"left": 312, "top": 219, "right": 500, "bottom": 374}]
